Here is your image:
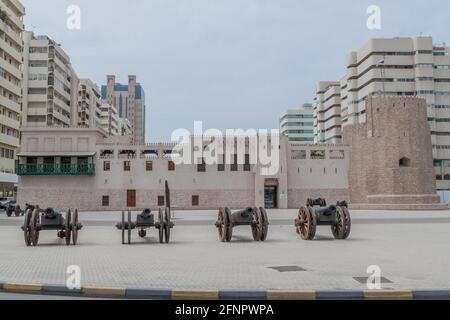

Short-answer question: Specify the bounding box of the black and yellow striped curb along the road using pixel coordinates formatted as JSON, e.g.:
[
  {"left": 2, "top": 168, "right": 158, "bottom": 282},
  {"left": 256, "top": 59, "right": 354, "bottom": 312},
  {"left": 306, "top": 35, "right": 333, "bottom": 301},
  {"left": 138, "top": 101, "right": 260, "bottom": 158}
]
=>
[{"left": 0, "top": 283, "right": 450, "bottom": 301}]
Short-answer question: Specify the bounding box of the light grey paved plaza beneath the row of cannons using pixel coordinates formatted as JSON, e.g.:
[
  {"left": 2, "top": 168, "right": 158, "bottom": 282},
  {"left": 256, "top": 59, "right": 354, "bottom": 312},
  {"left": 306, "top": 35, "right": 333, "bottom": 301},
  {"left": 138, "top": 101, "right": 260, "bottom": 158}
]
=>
[{"left": 0, "top": 210, "right": 450, "bottom": 292}]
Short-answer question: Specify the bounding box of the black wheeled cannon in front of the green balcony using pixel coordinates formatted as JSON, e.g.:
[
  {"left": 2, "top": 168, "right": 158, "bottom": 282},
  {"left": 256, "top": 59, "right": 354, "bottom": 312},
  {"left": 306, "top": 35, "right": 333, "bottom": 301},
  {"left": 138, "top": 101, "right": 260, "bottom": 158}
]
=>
[{"left": 22, "top": 205, "right": 83, "bottom": 247}]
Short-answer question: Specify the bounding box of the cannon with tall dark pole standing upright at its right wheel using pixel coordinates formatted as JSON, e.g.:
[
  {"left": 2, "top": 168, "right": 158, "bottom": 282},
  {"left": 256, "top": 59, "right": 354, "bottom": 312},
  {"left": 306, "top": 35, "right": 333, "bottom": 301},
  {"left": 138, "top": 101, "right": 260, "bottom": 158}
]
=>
[{"left": 116, "top": 181, "right": 175, "bottom": 244}]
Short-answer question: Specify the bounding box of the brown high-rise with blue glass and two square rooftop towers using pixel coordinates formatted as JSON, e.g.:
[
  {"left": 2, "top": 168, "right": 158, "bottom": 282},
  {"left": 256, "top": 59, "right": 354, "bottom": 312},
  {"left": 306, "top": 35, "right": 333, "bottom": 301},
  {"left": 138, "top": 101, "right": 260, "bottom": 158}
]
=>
[{"left": 102, "top": 76, "right": 146, "bottom": 143}]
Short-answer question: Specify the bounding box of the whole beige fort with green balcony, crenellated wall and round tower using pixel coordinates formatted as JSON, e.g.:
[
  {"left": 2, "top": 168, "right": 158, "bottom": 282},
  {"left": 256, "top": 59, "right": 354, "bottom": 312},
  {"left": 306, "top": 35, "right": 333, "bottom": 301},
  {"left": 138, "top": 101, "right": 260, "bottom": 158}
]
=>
[{"left": 17, "top": 96, "right": 445, "bottom": 211}]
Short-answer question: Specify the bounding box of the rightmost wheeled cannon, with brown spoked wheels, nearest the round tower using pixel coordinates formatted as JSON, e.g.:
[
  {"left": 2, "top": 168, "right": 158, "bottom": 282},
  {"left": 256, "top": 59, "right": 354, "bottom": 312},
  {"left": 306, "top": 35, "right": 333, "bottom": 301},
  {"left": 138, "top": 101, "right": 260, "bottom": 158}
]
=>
[{"left": 295, "top": 198, "right": 352, "bottom": 240}]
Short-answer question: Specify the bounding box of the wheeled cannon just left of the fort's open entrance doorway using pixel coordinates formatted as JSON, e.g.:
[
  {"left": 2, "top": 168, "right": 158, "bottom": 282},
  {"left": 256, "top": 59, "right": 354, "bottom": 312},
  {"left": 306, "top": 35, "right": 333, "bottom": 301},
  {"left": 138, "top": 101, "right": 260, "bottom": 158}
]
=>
[{"left": 215, "top": 207, "right": 269, "bottom": 242}]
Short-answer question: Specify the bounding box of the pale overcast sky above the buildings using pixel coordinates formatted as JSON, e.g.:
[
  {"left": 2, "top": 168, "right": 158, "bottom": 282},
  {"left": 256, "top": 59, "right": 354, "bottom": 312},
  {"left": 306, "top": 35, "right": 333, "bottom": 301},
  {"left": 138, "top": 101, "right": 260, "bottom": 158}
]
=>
[{"left": 21, "top": 0, "right": 450, "bottom": 141}]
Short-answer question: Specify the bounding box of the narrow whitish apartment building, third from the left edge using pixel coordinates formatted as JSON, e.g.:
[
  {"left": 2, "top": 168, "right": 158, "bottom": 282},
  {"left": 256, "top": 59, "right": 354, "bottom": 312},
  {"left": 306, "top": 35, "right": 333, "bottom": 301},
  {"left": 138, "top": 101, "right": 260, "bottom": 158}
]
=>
[{"left": 77, "top": 79, "right": 103, "bottom": 128}]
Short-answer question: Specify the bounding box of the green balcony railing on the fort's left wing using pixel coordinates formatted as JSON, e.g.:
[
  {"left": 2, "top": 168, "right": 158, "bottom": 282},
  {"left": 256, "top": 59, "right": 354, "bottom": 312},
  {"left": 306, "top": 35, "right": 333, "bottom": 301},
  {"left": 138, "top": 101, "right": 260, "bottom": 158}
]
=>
[{"left": 17, "top": 164, "right": 95, "bottom": 176}]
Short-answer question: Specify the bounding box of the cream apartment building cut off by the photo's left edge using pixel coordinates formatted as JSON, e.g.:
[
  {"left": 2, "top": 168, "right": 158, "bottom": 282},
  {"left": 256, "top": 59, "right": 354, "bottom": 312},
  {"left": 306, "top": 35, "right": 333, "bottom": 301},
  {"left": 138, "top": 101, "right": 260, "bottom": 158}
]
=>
[{"left": 0, "top": 0, "right": 25, "bottom": 175}]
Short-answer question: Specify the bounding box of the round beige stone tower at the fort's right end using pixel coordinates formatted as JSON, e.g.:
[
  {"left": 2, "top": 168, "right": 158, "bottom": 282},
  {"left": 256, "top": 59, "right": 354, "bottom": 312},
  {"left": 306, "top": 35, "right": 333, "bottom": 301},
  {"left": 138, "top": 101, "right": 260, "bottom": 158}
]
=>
[{"left": 344, "top": 96, "right": 439, "bottom": 208}]
